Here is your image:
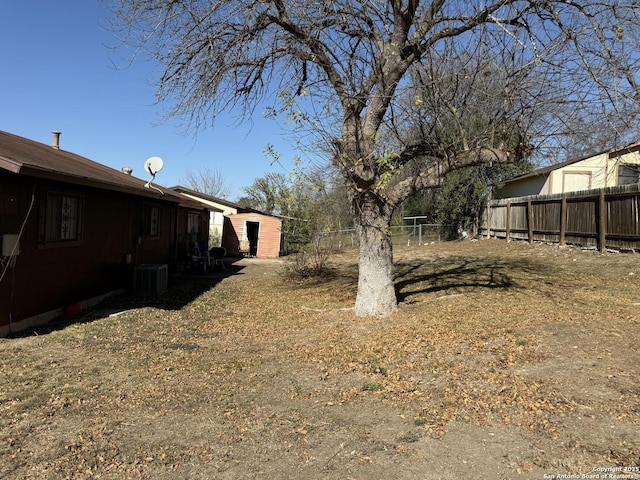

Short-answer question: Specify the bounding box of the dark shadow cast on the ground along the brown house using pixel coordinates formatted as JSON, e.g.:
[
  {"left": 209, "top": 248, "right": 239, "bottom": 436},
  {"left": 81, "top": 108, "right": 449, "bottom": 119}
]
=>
[{"left": 8, "top": 258, "right": 245, "bottom": 338}]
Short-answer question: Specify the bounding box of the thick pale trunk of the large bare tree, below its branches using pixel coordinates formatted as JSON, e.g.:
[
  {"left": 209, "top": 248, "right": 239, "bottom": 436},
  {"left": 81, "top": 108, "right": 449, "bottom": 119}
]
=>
[{"left": 355, "top": 193, "right": 398, "bottom": 317}]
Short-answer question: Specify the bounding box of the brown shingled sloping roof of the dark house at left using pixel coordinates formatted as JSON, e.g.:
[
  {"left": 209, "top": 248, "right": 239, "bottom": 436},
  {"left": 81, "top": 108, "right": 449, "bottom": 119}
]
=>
[{"left": 0, "top": 130, "right": 202, "bottom": 208}]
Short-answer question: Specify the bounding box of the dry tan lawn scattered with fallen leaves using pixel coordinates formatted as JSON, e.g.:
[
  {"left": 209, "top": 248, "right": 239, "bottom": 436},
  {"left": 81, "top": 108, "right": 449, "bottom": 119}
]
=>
[{"left": 0, "top": 240, "right": 640, "bottom": 480}]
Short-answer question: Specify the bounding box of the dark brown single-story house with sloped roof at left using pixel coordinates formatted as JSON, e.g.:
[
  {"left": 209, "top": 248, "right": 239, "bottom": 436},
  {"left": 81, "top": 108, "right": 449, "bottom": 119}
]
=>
[{"left": 0, "top": 131, "right": 209, "bottom": 336}]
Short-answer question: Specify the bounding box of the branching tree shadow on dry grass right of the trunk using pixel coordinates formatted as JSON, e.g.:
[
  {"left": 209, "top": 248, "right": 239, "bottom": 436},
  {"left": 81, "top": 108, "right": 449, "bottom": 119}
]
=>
[{"left": 395, "top": 256, "right": 547, "bottom": 302}]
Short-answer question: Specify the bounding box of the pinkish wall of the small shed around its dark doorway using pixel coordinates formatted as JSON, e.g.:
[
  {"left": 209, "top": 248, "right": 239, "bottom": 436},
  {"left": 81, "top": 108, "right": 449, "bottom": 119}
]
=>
[{"left": 222, "top": 213, "right": 282, "bottom": 258}]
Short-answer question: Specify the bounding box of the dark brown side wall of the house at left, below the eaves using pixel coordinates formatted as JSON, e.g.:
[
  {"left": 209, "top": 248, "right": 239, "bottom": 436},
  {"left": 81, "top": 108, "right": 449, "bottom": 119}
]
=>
[{"left": 0, "top": 170, "right": 178, "bottom": 336}]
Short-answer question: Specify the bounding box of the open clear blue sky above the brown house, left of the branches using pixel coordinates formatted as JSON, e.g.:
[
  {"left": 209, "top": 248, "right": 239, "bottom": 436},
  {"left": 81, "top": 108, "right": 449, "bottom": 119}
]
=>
[{"left": 0, "top": 0, "right": 300, "bottom": 199}]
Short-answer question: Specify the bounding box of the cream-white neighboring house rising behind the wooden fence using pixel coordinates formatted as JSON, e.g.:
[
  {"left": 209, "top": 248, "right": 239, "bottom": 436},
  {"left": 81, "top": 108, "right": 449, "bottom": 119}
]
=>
[{"left": 494, "top": 142, "right": 640, "bottom": 198}]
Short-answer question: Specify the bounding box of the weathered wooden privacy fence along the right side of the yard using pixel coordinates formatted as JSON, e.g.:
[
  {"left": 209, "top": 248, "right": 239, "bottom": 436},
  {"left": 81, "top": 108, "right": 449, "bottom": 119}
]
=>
[{"left": 480, "top": 184, "right": 640, "bottom": 252}]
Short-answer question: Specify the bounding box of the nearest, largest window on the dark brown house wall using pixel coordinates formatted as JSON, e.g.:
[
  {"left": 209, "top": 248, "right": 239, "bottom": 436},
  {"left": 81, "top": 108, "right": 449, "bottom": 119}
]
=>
[{"left": 40, "top": 192, "right": 84, "bottom": 243}]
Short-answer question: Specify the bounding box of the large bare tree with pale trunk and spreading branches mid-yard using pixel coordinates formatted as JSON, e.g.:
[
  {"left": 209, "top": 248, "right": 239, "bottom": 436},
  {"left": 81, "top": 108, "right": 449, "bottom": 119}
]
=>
[{"left": 112, "top": 0, "right": 640, "bottom": 315}]
